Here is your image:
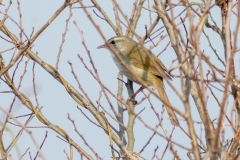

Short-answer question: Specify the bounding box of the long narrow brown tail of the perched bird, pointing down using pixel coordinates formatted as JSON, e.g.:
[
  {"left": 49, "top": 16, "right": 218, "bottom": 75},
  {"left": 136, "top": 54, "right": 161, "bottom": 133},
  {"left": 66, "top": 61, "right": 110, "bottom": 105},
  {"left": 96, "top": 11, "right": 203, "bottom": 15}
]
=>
[{"left": 155, "top": 79, "right": 179, "bottom": 126}]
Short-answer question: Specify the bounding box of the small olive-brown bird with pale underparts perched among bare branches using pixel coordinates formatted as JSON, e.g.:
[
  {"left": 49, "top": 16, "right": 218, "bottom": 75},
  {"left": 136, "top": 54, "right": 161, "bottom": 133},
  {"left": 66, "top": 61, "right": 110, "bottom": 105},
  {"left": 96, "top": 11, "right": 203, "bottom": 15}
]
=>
[{"left": 97, "top": 36, "right": 179, "bottom": 126}]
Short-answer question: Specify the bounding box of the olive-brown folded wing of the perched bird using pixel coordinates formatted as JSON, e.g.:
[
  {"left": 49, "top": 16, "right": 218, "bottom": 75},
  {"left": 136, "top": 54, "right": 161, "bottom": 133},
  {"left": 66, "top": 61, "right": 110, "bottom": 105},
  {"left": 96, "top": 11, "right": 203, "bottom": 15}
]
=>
[{"left": 127, "top": 44, "right": 172, "bottom": 80}]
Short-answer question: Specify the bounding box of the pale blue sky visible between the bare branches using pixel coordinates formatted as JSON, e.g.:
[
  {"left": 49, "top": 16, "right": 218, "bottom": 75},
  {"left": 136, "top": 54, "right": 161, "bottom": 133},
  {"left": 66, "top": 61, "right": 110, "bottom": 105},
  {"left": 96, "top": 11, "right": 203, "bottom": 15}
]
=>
[{"left": 0, "top": 0, "right": 239, "bottom": 160}]
